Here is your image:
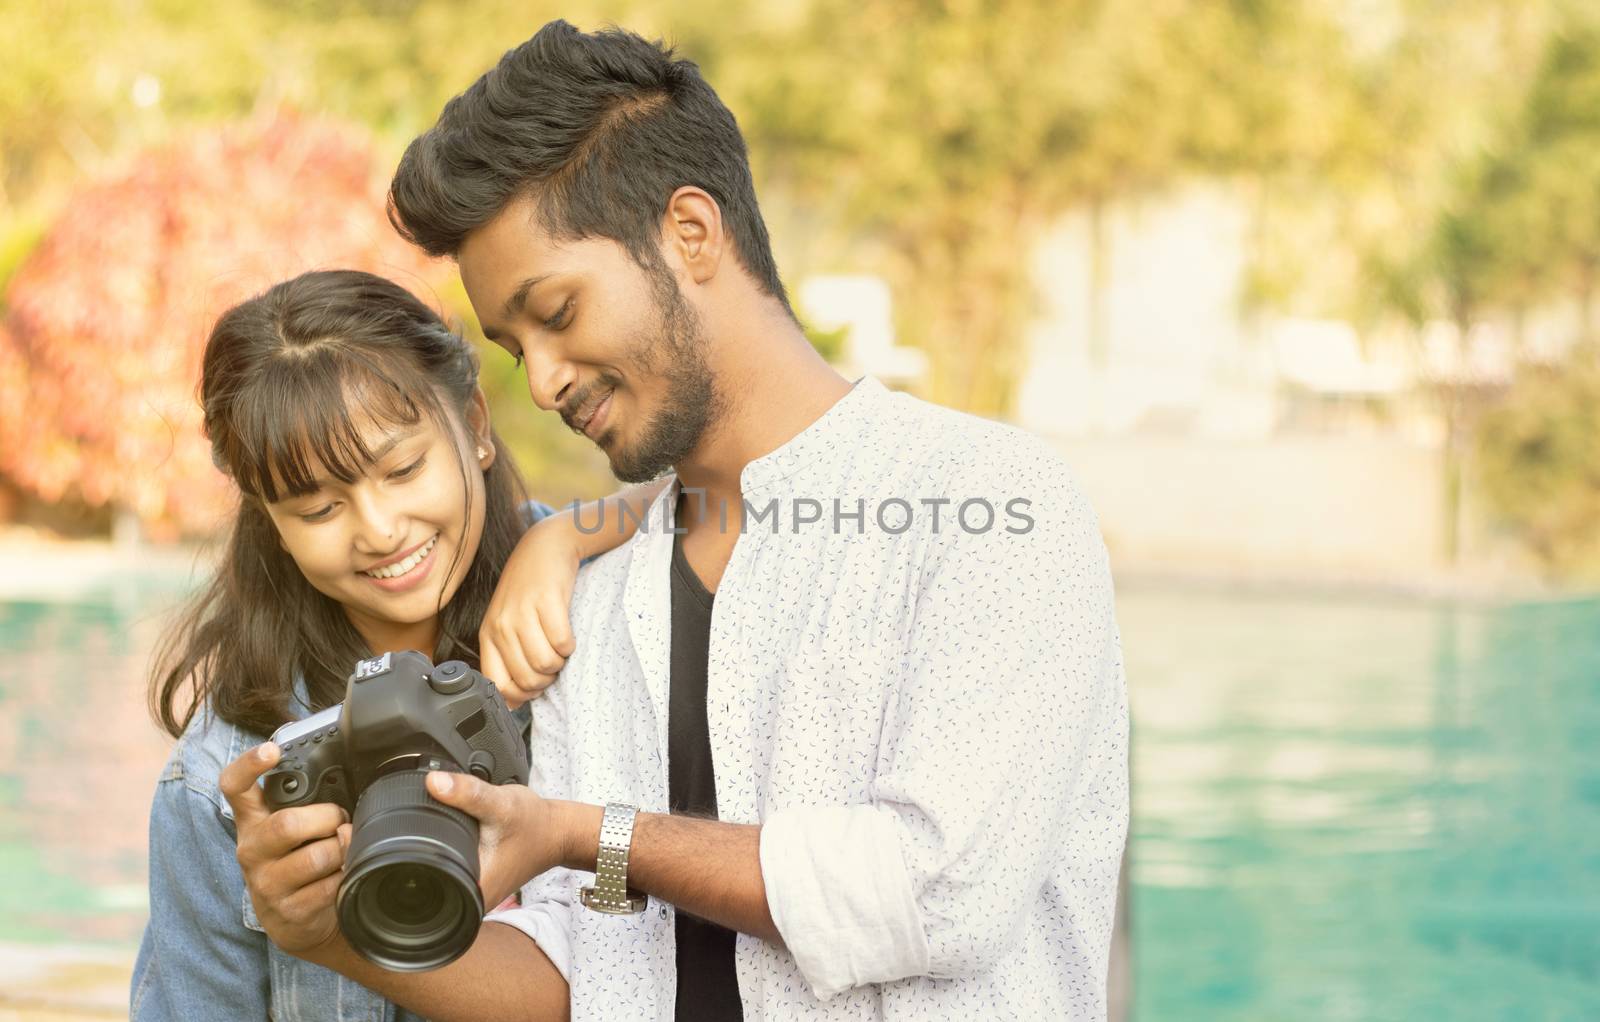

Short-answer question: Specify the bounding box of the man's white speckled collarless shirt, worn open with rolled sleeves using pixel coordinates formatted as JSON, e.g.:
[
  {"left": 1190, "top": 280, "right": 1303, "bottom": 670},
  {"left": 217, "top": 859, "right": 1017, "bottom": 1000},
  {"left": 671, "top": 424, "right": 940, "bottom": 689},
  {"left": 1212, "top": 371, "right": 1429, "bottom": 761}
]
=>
[{"left": 491, "top": 377, "right": 1128, "bottom": 1022}]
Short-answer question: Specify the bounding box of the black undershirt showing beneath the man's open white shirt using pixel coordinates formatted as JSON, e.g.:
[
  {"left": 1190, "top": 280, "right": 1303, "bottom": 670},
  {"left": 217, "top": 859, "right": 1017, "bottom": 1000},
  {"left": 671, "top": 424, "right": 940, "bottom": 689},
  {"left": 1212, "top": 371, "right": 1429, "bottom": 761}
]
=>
[{"left": 667, "top": 514, "right": 744, "bottom": 1022}]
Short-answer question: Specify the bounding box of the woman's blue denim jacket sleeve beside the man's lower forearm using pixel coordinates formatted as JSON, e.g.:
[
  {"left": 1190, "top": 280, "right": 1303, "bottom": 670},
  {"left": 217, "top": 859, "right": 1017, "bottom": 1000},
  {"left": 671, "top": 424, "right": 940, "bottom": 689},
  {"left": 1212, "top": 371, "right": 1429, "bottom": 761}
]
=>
[{"left": 130, "top": 763, "right": 270, "bottom": 1022}]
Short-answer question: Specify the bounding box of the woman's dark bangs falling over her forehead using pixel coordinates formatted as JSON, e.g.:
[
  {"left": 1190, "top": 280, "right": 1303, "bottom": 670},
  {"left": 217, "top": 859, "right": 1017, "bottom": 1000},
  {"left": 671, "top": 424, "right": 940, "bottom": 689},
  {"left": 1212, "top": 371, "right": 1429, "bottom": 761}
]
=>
[{"left": 230, "top": 350, "right": 434, "bottom": 504}]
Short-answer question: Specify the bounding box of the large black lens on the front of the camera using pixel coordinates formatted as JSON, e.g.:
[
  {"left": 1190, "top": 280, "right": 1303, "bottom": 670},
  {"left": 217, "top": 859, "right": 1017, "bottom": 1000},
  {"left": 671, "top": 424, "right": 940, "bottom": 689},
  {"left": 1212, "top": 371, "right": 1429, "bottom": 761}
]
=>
[{"left": 338, "top": 771, "right": 483, "bottom": 972}]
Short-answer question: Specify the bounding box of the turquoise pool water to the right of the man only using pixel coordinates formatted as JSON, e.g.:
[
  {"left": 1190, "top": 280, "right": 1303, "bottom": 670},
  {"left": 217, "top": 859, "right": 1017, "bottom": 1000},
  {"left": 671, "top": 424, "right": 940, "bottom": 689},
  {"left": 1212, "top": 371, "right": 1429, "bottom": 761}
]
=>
[{"left": 1120, "top": 592, "right": 1600, "bottom": 1022}]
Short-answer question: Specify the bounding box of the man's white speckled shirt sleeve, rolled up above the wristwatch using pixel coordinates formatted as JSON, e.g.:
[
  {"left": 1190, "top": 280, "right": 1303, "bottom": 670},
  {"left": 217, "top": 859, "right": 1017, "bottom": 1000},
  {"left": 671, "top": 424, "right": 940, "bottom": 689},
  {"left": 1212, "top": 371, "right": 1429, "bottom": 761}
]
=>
[{"left": 760, "top": 470, "right": 1128, "bottom": 998}]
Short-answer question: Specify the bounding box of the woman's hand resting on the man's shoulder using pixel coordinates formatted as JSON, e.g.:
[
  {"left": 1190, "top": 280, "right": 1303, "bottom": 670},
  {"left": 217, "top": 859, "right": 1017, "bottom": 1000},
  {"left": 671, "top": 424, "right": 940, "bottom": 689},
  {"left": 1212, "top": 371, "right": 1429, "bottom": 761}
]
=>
[{"left": 478, "top": 513, "right": 582, "bottom": 709}]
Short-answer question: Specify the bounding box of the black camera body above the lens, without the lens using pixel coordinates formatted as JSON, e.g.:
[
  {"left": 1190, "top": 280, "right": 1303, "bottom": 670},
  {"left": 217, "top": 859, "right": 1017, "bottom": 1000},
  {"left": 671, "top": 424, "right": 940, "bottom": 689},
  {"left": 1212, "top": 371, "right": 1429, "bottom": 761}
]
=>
[{"left": 264, "top": 651, "right": 528, "bottom": 814}]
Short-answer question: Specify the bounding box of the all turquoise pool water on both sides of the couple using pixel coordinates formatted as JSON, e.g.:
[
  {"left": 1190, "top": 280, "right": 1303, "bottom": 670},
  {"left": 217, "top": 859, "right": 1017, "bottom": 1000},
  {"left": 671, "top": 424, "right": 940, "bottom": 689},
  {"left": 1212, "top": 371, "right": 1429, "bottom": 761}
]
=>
[{"left": 0, "top": 582, "right": 1600, "bottom": 1022}]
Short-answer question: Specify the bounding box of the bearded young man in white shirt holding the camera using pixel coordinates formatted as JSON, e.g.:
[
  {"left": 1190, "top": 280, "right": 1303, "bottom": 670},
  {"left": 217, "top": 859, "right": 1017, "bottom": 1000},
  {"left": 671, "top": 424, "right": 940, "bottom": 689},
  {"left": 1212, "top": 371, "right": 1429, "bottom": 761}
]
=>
[{"left": 224, "top": 22, "right": 1128, "bottom": 1020}]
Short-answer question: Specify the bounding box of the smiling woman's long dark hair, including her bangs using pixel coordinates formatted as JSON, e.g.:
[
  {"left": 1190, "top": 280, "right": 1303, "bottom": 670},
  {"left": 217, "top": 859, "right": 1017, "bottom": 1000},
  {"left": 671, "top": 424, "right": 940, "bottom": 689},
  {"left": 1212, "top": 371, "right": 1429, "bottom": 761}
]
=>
[{"left": 150, "top": 270, "right": 523, "bottom": 737}]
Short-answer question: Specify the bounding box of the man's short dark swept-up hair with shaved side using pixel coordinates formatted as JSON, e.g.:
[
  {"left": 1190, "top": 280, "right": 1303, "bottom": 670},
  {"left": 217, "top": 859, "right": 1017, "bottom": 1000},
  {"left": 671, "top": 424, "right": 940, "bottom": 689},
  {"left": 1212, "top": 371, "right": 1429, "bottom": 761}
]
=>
[{"left": 389, "top": 21, "right": 789, "bottom": 316}]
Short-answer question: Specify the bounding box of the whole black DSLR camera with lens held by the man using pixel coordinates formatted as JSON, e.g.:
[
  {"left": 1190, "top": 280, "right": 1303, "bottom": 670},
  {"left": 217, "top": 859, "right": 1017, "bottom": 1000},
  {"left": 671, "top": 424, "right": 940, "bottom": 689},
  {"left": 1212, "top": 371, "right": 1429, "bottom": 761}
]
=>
[{"left": 262, "top": 651, "right": 528, "bottom": 972}]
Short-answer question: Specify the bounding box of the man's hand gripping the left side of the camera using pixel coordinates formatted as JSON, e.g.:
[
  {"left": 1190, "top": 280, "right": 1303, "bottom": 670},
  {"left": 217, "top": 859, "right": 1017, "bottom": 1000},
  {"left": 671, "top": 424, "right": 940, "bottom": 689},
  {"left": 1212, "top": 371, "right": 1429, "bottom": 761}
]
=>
[{"left": 218, "top": 742, "right": 347, "bottom": 958}]
